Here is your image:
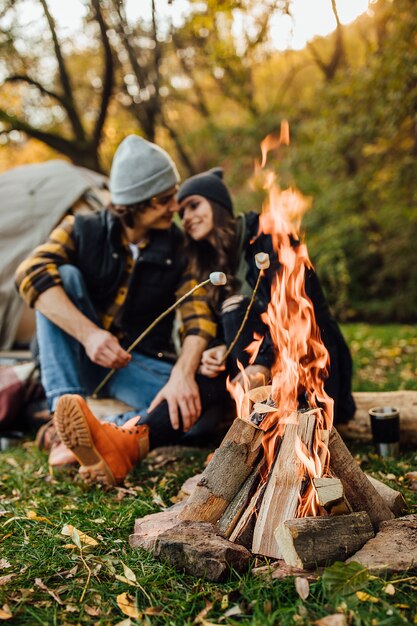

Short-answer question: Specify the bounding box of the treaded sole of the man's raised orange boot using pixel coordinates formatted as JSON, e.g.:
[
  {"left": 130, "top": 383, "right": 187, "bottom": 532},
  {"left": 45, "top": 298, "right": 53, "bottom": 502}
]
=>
[{"left": 54, "top": 395, "right": 117, "bottom": 485}]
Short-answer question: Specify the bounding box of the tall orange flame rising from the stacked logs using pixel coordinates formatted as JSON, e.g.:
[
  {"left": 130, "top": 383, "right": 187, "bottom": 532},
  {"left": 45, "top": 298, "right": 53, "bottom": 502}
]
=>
[{"left": 228, "top": 122, "right": 333, "bottom": 517}]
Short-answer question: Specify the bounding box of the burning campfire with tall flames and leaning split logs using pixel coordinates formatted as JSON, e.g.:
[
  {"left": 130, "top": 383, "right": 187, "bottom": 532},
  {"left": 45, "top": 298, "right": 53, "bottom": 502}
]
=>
[{"left": 131, "top": 132, "right": 404, "bottom": 580}]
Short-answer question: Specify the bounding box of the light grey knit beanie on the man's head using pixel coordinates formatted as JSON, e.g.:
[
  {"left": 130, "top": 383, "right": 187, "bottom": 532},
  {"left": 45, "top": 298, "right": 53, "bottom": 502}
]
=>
[{"left": 110, "top": 135, "right": 180, "bottom": 204}]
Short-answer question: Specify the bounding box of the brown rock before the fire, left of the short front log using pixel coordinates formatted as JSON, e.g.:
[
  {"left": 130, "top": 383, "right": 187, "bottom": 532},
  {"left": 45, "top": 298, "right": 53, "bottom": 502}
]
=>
[{"left": 152, "top": 521, "right": 252, "bottom": 581}]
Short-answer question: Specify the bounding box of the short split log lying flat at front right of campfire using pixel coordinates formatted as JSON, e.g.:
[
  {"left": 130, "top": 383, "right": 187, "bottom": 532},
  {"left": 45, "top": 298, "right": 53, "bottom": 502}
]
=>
[{"left": 275, "top": 512, "right": 374, "bottom": 569}]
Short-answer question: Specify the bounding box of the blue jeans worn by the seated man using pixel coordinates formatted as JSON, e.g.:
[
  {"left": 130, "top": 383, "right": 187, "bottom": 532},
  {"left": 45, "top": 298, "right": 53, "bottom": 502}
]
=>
[{"left": 36, "top": 265, "right": 173, "bottom": 425}]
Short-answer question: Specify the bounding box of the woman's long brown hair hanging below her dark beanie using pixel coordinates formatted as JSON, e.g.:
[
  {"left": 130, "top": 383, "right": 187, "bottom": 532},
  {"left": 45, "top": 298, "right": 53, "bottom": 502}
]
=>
[{"left": 185, "top": 199, "right": 239, "bottom": 310}]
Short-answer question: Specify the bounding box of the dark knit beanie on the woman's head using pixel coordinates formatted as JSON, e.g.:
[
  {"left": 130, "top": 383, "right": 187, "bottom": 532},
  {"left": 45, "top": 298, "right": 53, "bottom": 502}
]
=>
[{"left": 177, "top": 167, "right": 233, "bottom": 215}]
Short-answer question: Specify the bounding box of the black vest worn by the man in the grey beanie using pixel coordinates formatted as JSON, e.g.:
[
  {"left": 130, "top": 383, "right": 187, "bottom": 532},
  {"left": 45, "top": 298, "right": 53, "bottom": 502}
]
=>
[{"left": 74, "top": 211, "right": 185, "bottom": 360}]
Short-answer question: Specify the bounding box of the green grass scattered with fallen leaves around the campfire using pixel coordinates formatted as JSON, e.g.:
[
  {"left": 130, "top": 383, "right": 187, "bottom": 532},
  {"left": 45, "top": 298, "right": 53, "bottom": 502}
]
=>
[{"left": 0, "top": 325, "right": 417, "bottom": 626}]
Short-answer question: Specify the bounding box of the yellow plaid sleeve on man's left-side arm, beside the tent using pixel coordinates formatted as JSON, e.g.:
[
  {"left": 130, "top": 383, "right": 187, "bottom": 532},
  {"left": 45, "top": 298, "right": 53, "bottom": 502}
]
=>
[{"left": 15, "top": 215, "right": 75, "bottom": 306}]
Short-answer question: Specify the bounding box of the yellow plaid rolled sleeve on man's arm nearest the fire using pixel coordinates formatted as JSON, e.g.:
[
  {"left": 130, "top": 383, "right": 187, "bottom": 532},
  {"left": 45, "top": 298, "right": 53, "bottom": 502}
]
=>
[{"left": 176, "top": 272, "right": 217, "bottom": 341}]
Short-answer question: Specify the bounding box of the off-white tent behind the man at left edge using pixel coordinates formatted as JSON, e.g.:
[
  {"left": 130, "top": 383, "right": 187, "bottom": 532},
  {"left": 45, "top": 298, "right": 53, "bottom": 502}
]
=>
[{"left": 0, "top": 160, "right": 106, "bottom": 350}]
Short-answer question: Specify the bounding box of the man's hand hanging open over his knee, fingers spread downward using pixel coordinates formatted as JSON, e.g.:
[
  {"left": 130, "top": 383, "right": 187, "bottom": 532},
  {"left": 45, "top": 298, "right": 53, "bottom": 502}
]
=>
[{"left": 148, "top": 363, "right": 201, "bottom": 432}]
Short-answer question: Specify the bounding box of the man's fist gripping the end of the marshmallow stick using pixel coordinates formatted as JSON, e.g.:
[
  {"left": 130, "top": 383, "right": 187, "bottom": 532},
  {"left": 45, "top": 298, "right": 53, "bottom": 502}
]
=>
[{"left": 82, "top": 327, "right": 132, "bottom": 369}]
